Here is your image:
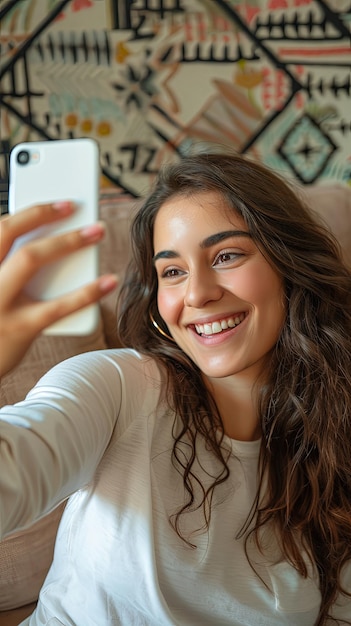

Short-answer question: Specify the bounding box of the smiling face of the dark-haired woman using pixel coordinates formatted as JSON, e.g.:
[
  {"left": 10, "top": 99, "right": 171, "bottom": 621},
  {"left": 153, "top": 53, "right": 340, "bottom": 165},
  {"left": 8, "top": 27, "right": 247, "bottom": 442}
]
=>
[{"left": 154, "top": 192, "right": 285, "bottom": 378}]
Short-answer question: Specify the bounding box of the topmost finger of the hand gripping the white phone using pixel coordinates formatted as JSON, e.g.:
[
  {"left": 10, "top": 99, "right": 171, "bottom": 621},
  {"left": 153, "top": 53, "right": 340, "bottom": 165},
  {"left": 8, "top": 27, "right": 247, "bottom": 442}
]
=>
[{"left": 0, "top": 200, "right": 76, "bottom": 260}]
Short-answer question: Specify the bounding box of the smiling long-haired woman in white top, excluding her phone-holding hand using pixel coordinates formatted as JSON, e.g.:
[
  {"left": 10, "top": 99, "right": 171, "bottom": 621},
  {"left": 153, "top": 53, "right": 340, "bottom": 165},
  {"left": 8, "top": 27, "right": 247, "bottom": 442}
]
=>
[{"left": 0, "top": 153, "right": 351, "bottom": 626}]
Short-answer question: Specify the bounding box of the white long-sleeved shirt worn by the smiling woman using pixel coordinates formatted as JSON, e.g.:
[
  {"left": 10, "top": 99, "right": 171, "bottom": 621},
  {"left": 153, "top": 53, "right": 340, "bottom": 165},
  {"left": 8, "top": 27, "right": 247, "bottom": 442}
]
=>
[{"left": 0, "top": 350, "right": 351, "bottom": 626}]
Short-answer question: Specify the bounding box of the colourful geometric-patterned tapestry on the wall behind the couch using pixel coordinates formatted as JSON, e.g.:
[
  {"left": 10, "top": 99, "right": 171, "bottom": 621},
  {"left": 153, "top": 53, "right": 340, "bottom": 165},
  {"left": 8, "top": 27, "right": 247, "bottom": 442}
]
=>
[{"left": 0, "top": 0, "right": 351, "bottom": 212}]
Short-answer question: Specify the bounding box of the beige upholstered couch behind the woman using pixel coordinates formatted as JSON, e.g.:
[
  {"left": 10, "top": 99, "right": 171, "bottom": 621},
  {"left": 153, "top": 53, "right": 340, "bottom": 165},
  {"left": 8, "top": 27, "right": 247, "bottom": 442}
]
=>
[{"left": 0, "top": 185, "right": 351, "bottom": 626}]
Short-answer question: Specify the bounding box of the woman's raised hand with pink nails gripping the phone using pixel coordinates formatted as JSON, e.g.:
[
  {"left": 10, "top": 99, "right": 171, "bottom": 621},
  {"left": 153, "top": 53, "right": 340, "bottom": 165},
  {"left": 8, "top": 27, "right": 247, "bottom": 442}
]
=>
[{"left": 0, "top": 202, "right": 117, "bottom": 376}]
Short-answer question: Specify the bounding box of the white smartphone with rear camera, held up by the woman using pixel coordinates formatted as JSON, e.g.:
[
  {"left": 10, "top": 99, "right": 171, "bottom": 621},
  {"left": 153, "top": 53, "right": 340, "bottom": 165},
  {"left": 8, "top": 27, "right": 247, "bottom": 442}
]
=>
[{"left": 9, "top": 139, "right": 100, "bottom": 335}]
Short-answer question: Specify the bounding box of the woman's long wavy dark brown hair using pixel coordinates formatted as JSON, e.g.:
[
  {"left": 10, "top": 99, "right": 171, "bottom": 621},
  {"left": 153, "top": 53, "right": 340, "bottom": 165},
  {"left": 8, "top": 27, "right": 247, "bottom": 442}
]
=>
[{"left": 118, "top": 151, "right": 351, "bottom": 626}]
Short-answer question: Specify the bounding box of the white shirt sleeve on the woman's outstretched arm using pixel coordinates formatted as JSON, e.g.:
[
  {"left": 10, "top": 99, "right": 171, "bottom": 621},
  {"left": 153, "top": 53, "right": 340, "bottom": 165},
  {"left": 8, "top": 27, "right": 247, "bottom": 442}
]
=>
[{"left": 0, "top": 351, "right": 129, "bottom": 538}]
